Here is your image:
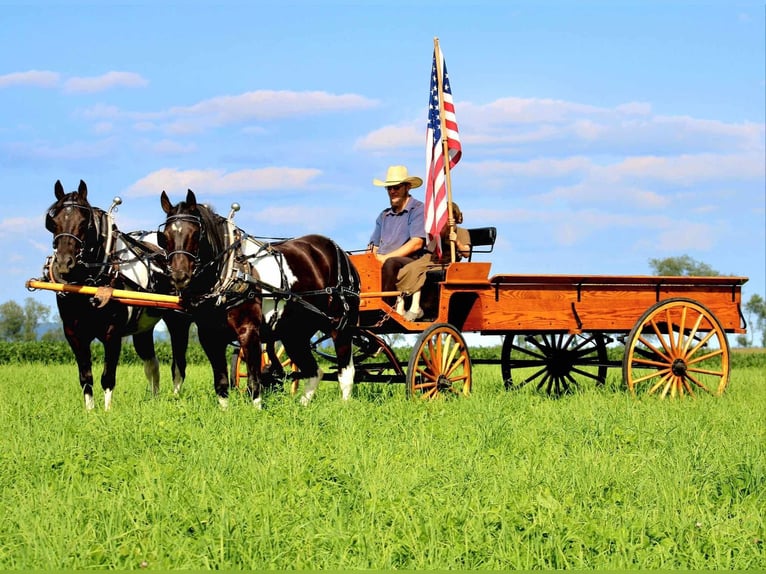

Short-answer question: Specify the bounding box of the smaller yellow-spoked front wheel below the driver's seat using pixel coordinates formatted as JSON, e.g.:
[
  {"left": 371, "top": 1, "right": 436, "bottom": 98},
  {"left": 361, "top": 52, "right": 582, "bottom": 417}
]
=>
[{"left": 407, "top": 323, "right": 471, "bottom": 399}]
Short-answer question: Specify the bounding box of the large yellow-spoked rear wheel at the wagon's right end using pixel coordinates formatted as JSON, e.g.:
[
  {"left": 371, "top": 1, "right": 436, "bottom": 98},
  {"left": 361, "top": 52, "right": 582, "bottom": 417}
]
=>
[{"left": 622, "top": 298, "right": 731, "bottom": 398}]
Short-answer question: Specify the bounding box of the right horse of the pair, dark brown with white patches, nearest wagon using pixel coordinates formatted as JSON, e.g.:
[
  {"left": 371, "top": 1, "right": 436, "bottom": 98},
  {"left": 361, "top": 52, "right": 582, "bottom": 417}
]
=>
[{"left": 158, "top": 190, "right": 359, "bottom": 408}]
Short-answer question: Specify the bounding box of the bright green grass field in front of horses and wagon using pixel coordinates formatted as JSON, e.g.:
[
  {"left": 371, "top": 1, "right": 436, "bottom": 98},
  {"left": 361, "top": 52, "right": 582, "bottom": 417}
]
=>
[{"left": 0, "top": 363, "right": 766, "bottom": 570}]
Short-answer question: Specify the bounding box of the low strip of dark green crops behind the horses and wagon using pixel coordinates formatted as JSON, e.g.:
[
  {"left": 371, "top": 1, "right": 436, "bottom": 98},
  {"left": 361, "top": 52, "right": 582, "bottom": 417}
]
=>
[{"left": 0, "top": 340, "right": 766, "bottom": 369}]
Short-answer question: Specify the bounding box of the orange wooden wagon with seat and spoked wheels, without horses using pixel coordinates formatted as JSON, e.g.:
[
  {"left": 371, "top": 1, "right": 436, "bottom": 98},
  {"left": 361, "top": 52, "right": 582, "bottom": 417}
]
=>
[{"left": 232, "top": 223, "right": 747, "bottom": 398}]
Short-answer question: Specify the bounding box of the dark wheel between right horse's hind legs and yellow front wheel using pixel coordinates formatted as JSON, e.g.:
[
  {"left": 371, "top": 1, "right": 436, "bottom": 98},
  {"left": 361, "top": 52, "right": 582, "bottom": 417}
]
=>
[{"left": 312, "top": 329, "right": 404, "bottom": 383}]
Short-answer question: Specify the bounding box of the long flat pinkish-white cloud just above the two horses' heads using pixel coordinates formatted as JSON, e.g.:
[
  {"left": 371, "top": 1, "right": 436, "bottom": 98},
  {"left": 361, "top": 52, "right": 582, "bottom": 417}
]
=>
[{"left": 126, "top": 167, "right": 321, "bottom": 197}]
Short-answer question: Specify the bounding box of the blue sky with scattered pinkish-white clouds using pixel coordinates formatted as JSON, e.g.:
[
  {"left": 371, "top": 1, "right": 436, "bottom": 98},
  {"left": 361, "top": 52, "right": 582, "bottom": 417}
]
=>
[{"left": 0, "top": 0, "right": 766, "bottom": 338}]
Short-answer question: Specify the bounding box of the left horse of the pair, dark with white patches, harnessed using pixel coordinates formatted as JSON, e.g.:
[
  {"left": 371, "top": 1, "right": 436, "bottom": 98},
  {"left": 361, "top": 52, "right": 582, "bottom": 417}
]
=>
[{"left": 45, "top": 180, "right": 191, "bottom": 410}]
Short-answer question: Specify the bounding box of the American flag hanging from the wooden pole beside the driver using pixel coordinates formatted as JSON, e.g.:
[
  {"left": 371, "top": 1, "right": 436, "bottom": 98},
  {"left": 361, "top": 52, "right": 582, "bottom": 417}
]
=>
[{"left": 425, "top": 48, "right": 463, "bottom": 254}]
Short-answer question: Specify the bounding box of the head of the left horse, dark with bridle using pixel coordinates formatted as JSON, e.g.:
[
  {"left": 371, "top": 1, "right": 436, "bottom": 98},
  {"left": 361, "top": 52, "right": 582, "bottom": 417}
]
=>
[{"left": 45, "top": 180, "right": 98, "bottom": 281}]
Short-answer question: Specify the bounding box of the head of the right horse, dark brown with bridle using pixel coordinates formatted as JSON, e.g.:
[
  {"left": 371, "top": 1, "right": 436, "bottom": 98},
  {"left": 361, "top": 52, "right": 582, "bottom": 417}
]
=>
[{"left": 157, "top": 189, "right": 204, "bottom": 293}]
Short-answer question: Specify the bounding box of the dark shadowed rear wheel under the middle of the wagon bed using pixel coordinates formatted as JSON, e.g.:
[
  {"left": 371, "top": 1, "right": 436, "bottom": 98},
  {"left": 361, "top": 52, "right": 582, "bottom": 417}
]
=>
[{"left": 500, "top": 333, "right": 608, "bottom": 396}]
